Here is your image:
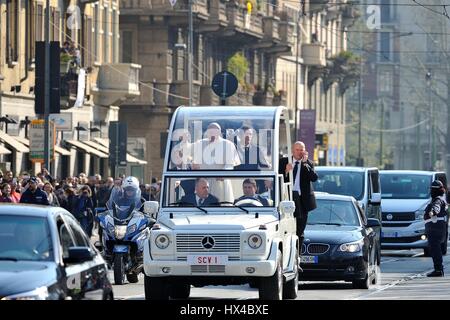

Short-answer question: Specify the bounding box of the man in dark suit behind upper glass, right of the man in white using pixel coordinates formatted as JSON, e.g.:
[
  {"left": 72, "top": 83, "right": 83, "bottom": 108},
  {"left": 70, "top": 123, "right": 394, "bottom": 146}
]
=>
[{"left": 234, "top": 126, "right": 270, "bottom": 170}]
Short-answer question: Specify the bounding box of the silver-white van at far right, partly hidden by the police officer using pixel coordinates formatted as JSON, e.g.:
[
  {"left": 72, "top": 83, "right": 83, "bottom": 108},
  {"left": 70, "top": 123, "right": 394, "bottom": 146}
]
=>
[{"left": 380, "top": 170, "right": 448, "bottom": 256}]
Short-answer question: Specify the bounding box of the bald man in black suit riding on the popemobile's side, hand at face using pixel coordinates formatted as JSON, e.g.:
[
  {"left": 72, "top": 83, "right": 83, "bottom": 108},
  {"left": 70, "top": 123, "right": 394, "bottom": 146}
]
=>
[{"left": 279, "top": 141, "right": 318, "bottom": 264}]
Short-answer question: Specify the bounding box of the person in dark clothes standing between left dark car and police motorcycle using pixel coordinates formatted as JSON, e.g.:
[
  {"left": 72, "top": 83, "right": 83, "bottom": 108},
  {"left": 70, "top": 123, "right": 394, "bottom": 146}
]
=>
[{"left": 72, "top": 186, "right": 94, "bottom": 237}]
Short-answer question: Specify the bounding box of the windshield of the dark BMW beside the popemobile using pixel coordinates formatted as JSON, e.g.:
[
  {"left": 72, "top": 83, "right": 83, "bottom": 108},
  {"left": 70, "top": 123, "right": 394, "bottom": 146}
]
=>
[{"left": 308, "top": 199, "right": 359, "bottom": 226}]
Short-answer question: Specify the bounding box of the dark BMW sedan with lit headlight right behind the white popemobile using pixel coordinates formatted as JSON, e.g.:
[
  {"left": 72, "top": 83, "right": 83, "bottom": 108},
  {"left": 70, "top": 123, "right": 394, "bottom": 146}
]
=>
[{"left": 300, "top": 193, "right": 381, "bottom": 289}]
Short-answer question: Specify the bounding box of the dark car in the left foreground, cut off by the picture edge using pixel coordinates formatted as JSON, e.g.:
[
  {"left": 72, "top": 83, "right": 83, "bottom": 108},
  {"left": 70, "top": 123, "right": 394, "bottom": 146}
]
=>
[{"left": 0, "top": 204, "right": 113, "bottom": 300}]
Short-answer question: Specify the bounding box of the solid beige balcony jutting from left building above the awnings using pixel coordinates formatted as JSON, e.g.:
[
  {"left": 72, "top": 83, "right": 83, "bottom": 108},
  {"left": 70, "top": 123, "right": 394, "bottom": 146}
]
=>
[{"left": 92, "top": 63, "right": 141, "bottom": 106}]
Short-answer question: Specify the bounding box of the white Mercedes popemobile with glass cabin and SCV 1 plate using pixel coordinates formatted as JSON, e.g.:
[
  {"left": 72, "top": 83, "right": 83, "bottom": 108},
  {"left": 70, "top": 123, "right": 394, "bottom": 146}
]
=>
[{"left": 144, "top": 106, "right": 299, "bottom": 300}]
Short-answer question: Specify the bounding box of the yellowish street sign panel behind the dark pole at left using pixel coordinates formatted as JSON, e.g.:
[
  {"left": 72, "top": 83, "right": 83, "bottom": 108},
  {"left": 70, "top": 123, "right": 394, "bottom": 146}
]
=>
[{"left": 29, "top": 119, "right": 56, "bottom": 163}]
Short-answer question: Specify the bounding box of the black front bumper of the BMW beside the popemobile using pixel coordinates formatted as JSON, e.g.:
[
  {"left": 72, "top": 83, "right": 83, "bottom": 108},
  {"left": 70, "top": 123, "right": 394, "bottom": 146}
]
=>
[{"left": 299, "top": 252, "right": 367, "bottom": 281}]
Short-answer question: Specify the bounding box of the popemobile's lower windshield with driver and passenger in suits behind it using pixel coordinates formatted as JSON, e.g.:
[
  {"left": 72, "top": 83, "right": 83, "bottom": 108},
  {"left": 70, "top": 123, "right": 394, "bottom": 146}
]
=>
[{"left": 163, "top": 176, "right": 275, "bottom": 208}]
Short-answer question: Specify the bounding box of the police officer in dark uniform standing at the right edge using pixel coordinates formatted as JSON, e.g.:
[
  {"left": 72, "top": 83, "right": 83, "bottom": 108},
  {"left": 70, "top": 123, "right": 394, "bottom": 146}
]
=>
[{"left": 424, "top": 180, "right": 447, "bottom": 277}]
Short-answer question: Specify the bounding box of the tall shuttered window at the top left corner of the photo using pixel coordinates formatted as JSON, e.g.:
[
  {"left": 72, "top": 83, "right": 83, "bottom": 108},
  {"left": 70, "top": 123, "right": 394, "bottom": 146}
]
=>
[{"left": 6, "top": 0, "right": 19, "bottom": 66}]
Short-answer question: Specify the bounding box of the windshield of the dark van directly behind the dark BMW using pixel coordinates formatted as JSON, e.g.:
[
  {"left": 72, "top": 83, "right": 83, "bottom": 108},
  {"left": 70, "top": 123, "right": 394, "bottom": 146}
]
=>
[{"left": 314, "top": 169, "right": 364, "bottom": 200}]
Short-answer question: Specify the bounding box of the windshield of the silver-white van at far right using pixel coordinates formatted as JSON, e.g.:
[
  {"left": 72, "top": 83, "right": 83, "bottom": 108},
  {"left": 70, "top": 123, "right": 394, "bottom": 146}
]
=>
[{"left": 380, "top": 173, "right": 431, "bottom": 199}]
